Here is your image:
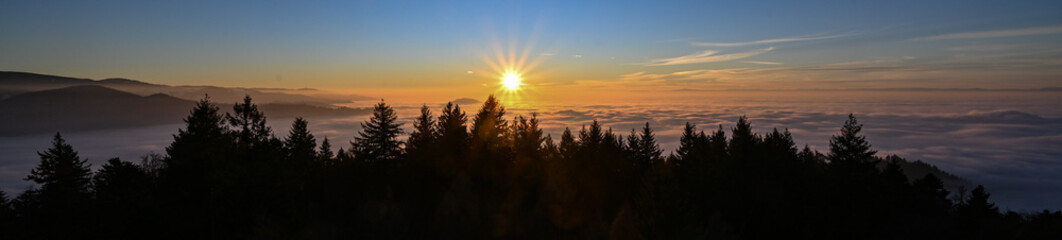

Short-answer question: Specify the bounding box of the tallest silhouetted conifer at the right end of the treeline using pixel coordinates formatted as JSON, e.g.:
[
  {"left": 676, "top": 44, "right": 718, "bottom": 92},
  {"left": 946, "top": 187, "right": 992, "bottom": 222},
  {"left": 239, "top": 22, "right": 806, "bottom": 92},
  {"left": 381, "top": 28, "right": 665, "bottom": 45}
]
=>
[{"left": 826, "top": 114, "right": 877, "bottom": 174}]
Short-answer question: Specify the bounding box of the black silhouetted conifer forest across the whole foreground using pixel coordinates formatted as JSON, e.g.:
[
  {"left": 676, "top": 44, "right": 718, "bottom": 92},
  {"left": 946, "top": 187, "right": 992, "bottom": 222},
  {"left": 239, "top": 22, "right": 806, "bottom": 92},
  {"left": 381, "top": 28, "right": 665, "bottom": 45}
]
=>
[{"left": 0, "top": 96, "right": 1062, "bottom": 239}]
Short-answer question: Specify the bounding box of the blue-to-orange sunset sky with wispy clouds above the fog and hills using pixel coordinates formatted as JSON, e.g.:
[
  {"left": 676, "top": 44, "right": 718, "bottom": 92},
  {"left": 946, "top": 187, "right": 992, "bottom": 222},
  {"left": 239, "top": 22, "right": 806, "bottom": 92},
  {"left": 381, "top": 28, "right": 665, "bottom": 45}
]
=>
[{"left": 0, "top": 0, "right": 1062, "bottom": 99}]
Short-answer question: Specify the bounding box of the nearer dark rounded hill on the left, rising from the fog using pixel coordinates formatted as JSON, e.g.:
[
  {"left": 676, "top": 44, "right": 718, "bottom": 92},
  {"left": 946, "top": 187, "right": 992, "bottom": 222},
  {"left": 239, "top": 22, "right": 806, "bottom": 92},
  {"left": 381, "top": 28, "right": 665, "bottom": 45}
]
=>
[{"left": 0, "top": 83, "right": 370, "bottom": 136}]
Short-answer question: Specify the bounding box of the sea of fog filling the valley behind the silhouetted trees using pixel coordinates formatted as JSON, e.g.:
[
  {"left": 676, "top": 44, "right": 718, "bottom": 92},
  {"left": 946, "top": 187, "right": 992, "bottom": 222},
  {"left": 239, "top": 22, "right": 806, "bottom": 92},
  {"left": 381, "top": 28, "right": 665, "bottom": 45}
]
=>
[{"left": 0, "top": 91, "right": 1062, "bottom": 210}]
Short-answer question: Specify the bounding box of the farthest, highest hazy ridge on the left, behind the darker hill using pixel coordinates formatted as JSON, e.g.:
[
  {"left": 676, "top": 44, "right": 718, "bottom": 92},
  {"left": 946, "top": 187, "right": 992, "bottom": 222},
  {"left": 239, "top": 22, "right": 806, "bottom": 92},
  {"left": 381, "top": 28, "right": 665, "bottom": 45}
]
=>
[{"left": 0, "top": 71, "right": 375, "bottom": 106}]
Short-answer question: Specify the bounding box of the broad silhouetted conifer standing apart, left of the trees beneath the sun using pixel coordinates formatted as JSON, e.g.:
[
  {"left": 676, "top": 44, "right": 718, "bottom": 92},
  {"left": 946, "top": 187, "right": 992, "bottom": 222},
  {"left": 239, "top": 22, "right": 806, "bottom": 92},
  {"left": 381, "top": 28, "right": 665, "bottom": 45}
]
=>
[{"left": 350, "top": 100, "right": 402, "bottom": 164}]
